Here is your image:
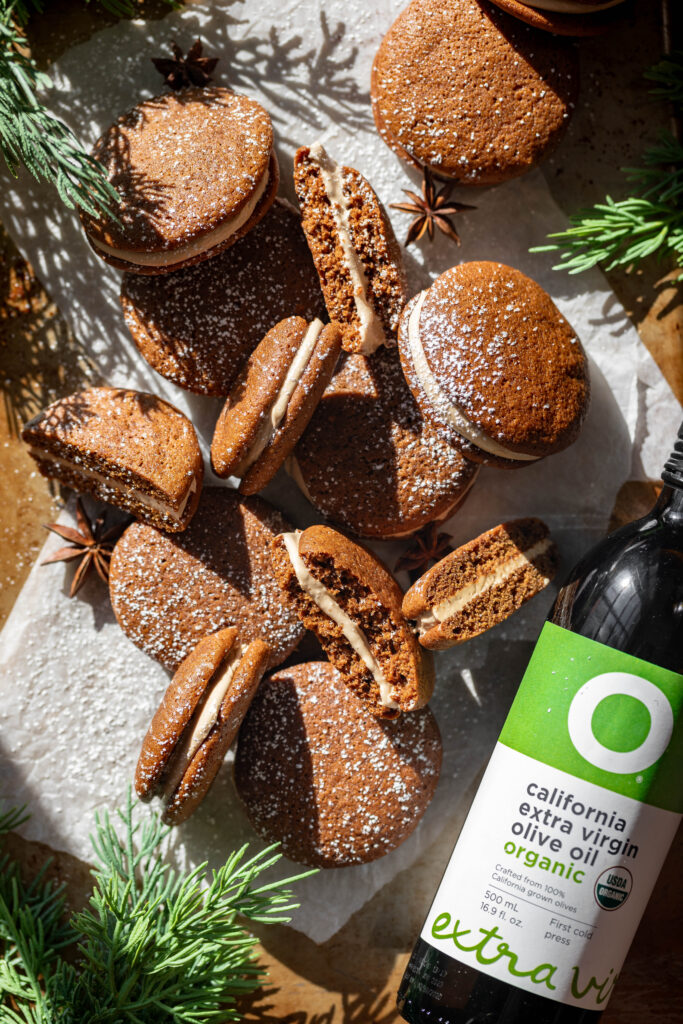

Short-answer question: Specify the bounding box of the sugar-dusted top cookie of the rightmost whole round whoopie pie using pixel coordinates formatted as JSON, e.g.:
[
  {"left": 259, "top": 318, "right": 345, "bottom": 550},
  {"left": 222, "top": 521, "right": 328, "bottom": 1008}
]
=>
[{"left": 419, "top": 262, "right": 588, "bottom": 443}]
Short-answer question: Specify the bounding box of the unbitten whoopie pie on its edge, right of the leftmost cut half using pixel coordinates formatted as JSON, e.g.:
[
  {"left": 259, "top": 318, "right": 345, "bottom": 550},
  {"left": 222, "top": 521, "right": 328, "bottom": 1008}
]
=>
[{"left": 211, "top": 316, "right": 342, "bottom": 495}]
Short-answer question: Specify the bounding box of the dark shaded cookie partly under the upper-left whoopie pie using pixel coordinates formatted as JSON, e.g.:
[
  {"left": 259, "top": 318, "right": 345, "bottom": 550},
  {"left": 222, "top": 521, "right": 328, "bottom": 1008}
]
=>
[{"left": 121, "top": 200, "right": 325, "bottom": 397}]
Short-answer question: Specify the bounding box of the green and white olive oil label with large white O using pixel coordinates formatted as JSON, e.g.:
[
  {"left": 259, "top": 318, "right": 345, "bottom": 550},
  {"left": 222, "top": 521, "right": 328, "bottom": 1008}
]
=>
[{"left": 422, "top": 623, "right": 683, "bottom": 1010}]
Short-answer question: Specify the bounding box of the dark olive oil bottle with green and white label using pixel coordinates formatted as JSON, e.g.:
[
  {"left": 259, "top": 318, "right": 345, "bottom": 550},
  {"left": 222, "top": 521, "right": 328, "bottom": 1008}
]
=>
[{"left": 397, "top": 426, "right": 683, "bottom": 1024}]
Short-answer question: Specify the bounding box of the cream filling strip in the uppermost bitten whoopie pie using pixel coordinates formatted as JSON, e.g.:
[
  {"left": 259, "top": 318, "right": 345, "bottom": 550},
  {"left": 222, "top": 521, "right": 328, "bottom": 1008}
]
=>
[{"left": 308, "top": 142, "right": 387, "bottom": 355}]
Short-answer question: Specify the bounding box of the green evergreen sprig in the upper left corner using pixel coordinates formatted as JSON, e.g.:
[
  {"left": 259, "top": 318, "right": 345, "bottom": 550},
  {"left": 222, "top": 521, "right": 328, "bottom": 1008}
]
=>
[{"left": 0, "top": 0, "right": 177, "bottom": 214}]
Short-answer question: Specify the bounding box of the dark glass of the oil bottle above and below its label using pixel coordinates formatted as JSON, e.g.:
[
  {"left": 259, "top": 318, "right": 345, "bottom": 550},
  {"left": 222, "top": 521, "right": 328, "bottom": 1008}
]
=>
[{"left": 397, "top": 426, "right": 683, "bottom": 1024}]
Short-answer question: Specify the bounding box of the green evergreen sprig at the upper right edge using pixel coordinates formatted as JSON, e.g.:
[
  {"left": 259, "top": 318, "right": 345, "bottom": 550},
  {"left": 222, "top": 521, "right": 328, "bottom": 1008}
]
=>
[{"left": 531, "top": 52, "right": 683, "bottom": 273}]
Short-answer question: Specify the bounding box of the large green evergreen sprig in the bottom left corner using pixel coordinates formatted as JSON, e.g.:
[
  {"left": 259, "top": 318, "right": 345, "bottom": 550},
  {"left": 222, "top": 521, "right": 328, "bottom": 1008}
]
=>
[{"left": 0, "top": 795, "right": 310, "bottom": 1024}]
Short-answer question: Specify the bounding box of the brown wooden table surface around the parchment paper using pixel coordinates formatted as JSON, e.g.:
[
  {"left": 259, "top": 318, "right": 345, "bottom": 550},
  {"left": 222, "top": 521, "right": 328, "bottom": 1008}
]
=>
[{"left": 0, "top": 0, "right": 683, "bottom": 1024}]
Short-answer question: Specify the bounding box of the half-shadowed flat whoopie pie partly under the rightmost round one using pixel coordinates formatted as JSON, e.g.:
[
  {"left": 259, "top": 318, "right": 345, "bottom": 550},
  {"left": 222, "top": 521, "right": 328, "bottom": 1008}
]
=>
[{"left": 286, "top": 348, "right": 477, "bottom": 538}]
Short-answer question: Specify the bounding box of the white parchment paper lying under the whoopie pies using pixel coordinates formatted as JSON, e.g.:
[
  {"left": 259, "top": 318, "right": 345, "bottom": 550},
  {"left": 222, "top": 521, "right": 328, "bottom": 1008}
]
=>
[{"left": 0, "top": 0, "right": 680, "bottom": 942}]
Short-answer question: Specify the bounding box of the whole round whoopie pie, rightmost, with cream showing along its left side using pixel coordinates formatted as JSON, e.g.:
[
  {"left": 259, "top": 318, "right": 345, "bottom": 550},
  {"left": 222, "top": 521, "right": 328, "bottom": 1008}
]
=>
[{"left": 398, "top": 262, "right": 590, "bottom": 469}]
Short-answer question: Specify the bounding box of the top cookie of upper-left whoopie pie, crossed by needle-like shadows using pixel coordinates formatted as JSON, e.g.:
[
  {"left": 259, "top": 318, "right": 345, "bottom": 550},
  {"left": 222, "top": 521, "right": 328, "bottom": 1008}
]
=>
[{"left": 88, "top": 88, "right": 272, "bottom": 252}]
